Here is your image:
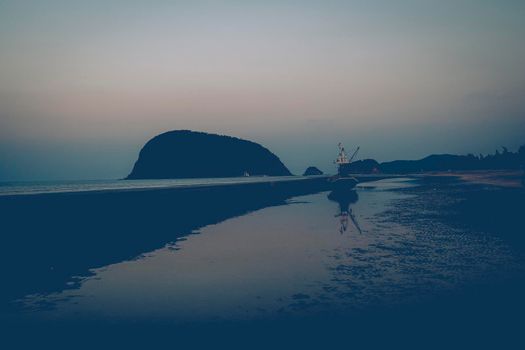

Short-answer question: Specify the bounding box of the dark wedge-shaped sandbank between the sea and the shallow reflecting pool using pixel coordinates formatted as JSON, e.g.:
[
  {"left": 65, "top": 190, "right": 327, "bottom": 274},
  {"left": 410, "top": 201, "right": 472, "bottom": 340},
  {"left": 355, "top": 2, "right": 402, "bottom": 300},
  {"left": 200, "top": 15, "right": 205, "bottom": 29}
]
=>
[{"left": 0, "top": 178, "right": 327, "bottom": 310}]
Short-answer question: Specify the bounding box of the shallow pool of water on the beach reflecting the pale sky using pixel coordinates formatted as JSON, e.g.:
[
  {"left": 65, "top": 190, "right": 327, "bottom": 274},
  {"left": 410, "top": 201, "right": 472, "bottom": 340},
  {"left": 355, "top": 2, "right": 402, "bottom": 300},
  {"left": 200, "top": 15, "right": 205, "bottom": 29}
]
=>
[{"left": 24, "top": 180, "right": 524, "bottom": 321}]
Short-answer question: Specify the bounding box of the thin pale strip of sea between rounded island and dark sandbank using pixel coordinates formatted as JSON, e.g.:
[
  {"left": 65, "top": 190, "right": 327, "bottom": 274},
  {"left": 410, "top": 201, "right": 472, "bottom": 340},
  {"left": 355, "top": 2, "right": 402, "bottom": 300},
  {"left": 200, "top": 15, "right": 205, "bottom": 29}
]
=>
[{"left": 0, "top": 176, "right": 316, "bottom": 196}]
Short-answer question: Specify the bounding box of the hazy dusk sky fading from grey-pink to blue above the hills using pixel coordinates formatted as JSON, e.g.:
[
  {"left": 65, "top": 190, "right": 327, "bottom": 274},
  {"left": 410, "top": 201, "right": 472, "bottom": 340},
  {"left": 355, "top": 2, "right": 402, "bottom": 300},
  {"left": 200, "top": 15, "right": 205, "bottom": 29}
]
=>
[{"left": 0, "top": 0, "right": 525, "bottom": 181}]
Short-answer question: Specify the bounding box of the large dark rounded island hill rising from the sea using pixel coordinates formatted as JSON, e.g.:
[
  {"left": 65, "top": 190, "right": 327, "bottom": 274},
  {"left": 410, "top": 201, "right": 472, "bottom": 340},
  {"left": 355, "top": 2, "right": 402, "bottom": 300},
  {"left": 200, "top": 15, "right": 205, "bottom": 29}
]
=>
[{"left": 127, "top": 130, "right": 292, "bottom": 179}]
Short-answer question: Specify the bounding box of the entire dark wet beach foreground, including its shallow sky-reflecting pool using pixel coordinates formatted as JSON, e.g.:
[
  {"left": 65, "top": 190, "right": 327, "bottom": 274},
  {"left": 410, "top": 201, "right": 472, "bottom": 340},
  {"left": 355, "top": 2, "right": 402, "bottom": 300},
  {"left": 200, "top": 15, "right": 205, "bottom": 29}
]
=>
[{"left": 0, "top": 176, "right": 525, "bottom": 348}]
